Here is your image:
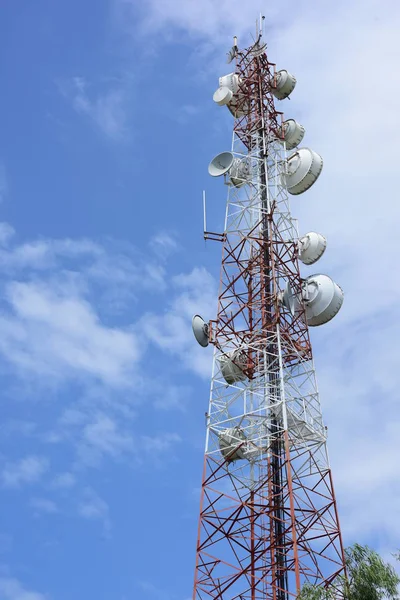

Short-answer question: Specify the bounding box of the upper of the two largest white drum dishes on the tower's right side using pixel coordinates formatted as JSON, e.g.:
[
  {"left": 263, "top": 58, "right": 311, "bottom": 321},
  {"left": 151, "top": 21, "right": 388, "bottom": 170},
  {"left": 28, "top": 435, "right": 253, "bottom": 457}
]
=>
[{"left": 283, "top": 148, "right": 323, "bottom": 195}]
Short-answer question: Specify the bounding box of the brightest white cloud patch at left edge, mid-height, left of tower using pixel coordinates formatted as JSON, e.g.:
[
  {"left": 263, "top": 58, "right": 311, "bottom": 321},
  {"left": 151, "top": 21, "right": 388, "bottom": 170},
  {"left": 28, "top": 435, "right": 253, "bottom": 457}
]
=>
[{"left": 0, "top": 282, "right": 139, "bottom": 386}]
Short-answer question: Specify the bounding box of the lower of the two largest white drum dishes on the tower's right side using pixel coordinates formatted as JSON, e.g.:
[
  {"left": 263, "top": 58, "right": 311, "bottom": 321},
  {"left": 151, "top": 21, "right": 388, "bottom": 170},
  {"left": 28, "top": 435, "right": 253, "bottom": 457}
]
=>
[{"left": 302, "top": 274, "right": 344, "bottom": 327}]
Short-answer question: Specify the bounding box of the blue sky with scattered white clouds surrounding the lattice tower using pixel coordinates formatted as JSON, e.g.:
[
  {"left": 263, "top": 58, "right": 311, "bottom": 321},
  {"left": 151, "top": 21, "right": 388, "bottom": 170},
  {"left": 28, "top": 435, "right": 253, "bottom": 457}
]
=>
[{"left": 0, "top": 0, "right": 400, "bottom": 600}]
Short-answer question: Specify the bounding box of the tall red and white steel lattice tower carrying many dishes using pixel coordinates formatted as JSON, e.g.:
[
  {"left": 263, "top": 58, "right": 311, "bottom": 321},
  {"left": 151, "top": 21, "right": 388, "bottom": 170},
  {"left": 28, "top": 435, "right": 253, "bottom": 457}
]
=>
[{"left": 193, "top": 17, "right": 344, "bottom": 600}]
